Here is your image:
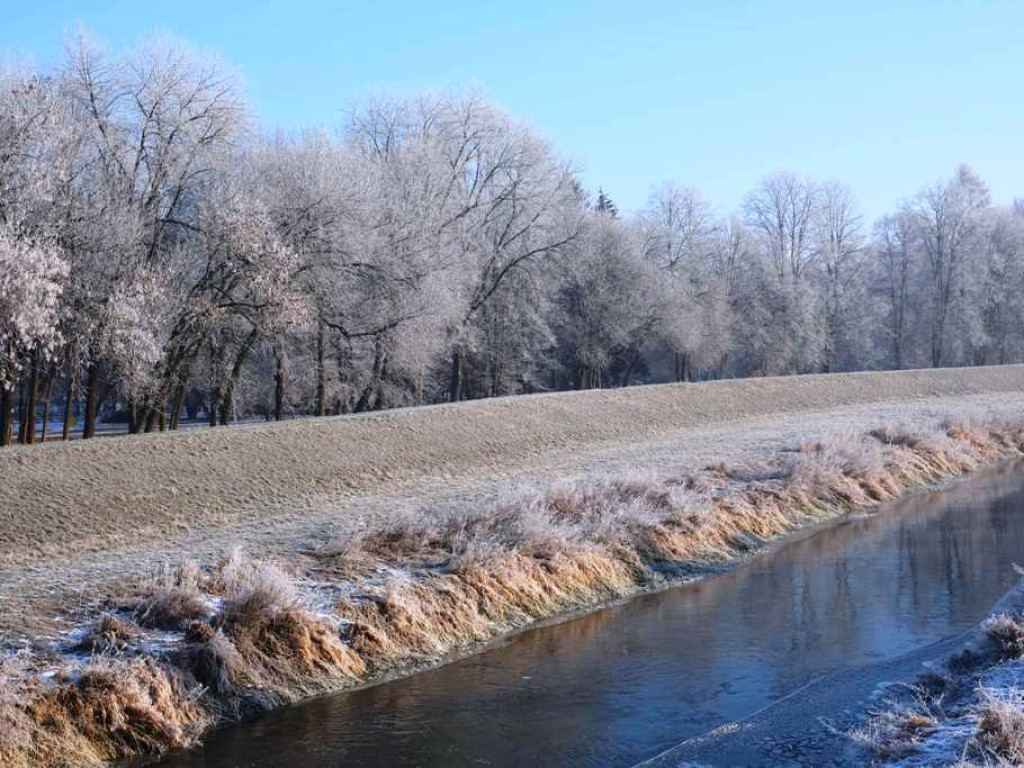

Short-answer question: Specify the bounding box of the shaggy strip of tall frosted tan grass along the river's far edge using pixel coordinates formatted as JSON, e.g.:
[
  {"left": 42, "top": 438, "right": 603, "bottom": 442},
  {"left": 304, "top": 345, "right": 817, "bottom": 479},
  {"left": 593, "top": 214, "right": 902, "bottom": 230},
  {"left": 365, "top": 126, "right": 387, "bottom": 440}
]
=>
[{"left": 6, "top": 403, "right": 1024, "bottom": 765}]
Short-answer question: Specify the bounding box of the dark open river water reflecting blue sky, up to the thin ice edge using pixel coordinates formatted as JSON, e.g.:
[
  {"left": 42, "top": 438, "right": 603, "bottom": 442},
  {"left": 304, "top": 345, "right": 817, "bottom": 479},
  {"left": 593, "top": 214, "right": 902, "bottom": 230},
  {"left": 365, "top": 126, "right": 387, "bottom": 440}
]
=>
[{"left": 146, "top": 462, "right": 1024, "bottom": 768}]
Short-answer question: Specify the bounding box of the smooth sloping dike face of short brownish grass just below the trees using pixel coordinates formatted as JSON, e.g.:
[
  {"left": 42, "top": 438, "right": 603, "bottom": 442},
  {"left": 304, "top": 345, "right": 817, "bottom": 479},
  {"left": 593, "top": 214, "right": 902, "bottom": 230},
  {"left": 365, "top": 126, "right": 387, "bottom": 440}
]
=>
[{"left": 0, "top": 366, "right": 1024, "bottom": 564}]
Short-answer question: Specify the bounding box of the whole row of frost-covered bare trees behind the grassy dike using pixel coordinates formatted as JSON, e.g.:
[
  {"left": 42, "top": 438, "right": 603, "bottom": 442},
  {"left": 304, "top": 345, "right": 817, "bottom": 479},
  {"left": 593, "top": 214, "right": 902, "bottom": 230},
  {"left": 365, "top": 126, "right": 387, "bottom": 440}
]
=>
[{"left": 0, "top": 37, "right": 1024, "bottom": 444}]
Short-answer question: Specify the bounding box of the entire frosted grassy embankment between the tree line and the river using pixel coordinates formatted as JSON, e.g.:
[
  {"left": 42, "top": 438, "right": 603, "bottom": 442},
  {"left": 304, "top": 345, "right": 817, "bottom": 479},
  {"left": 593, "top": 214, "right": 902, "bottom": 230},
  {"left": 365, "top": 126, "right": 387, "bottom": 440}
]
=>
[{"left": 0, "top": 367, "right": 1024, "bottom": 766}]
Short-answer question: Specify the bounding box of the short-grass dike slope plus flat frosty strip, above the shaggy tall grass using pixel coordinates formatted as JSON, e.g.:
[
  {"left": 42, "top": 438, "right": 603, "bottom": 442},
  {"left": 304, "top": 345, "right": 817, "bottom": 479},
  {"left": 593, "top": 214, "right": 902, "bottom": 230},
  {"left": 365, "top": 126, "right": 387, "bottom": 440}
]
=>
[{"left": 6, "top": 367, "right": 1024, "bottom": 644}]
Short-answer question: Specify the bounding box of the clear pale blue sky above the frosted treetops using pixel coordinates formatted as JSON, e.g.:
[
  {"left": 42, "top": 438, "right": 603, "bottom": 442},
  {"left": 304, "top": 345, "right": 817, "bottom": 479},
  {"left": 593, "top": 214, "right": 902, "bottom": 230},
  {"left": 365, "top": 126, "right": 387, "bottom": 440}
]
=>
[{"left": 0, "top": 0, "right": 1024, "bottom": 217}]
